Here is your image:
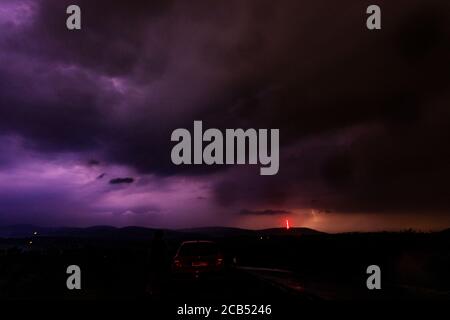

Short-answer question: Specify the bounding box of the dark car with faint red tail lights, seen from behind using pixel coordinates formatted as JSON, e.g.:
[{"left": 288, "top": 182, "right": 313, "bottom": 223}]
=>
[{"left": 172, "top": 240, "right": 225, "bottom": 277}]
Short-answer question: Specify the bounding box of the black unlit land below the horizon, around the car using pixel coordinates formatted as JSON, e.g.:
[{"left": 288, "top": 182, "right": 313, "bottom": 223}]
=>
[{"left": 0, "top": 228, "right": 450, "bottom": 304}]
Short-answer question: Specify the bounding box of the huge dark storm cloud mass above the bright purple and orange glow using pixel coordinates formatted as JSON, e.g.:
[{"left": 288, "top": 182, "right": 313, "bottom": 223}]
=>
[{"left": 0, "top": 0, "right": 450, "bottom": 221}]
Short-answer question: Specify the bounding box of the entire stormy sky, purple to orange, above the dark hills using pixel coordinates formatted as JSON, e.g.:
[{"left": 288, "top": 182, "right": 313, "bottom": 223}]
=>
[{"left": 0, "top": 0, "right": 450, "bottom": 231}]
